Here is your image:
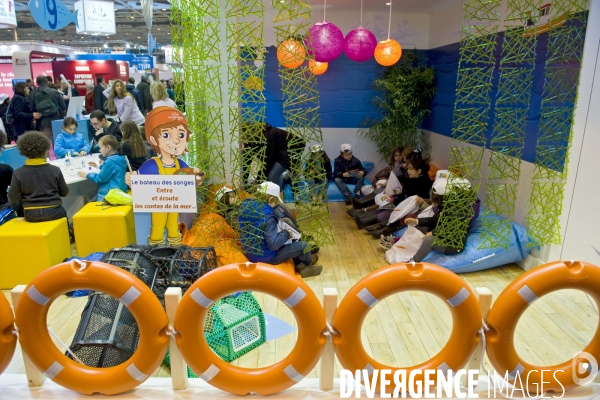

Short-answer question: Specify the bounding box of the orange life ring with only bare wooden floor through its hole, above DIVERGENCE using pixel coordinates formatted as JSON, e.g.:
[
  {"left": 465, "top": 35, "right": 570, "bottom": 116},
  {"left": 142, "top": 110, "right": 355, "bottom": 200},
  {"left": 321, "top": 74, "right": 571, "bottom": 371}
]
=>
[{"left": 333, "top": 263, "right": 482, "bottom": 393}]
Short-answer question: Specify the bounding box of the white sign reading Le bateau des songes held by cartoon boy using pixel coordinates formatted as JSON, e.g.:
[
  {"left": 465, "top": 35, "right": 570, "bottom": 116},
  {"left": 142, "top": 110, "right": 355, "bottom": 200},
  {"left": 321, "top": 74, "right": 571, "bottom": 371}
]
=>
[{"left": 131, "top": 175, "right": 198, "bottom": 213}]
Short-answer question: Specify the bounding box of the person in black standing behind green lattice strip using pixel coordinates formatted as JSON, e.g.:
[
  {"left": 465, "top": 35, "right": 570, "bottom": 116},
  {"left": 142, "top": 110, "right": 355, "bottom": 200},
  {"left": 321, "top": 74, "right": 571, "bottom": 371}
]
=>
[{"left": 242, "top": 122, "right": 291, "bottom": 187}]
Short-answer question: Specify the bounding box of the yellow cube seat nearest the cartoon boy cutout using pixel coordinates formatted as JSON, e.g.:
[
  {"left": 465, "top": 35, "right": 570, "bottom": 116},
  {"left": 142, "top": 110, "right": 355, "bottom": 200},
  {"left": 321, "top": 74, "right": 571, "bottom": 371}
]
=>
[{"left": 73, "top": 202, "right": 135, "bottom": 257}]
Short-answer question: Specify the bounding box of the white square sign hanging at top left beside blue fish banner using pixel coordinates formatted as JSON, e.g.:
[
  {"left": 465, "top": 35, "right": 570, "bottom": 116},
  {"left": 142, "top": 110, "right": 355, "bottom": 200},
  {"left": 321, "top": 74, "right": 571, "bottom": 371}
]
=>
[{"left": 75, "top": 0, "right": 116, "bottom": 35}]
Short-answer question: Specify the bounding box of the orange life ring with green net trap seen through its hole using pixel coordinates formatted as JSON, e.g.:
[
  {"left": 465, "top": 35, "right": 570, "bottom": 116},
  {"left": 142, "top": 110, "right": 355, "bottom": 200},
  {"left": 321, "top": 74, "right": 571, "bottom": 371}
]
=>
[{"left": 173, "top": 262, "right": 326, "bottom": 396}]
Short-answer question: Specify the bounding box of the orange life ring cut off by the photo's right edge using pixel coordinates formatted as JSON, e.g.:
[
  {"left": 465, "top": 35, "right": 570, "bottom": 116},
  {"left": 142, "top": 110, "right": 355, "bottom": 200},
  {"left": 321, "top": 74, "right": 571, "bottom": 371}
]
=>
[{"left": 486, "top": 261, "right": 600, "bottom": 393}]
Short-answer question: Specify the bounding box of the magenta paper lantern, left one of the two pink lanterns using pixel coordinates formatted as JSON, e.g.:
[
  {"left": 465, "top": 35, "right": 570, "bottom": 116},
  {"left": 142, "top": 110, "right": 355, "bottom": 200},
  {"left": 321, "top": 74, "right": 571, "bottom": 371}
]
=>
[{"left": 306, "top": 22, "right": 344, "bottom": 62}]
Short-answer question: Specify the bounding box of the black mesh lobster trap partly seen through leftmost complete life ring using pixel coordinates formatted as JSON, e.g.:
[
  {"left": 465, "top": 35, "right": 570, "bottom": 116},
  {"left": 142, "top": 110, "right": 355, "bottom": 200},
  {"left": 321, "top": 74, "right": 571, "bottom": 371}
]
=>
[{"left": 66, "top": 247, "right": 158, "bottom": 368}]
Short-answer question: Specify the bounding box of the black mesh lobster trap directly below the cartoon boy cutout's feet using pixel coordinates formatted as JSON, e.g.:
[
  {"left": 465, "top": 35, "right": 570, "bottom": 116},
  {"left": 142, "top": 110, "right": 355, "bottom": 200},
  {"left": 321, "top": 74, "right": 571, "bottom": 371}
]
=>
[{"left": 147, "top": 246, "right": 217, "bottom": 302}]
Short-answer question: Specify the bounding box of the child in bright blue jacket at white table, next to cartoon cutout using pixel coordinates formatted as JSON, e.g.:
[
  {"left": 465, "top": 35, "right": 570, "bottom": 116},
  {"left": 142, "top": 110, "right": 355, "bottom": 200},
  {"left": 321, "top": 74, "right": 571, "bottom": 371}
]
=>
[{"left": 78, "top": 135, "right": 127, "bottom": 201}]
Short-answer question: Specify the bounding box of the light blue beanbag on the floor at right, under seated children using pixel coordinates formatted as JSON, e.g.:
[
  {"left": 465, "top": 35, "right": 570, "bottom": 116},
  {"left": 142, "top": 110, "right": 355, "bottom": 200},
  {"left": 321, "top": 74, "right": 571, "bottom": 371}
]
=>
[{"left": 394, "top": 215, "right": 532, "bottom": 274}]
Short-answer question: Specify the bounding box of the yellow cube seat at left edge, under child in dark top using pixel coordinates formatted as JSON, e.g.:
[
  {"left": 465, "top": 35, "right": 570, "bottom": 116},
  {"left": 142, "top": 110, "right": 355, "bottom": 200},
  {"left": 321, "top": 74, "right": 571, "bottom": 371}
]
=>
[{"left": 0, "top": 218, "right": 72, "bottom": 289}]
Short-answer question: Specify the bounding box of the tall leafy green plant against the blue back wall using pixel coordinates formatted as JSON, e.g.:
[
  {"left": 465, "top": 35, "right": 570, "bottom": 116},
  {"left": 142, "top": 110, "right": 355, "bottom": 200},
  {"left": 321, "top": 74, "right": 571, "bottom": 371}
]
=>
[{"left": 360, "top": 51, "right": 435, "bottom": 159}]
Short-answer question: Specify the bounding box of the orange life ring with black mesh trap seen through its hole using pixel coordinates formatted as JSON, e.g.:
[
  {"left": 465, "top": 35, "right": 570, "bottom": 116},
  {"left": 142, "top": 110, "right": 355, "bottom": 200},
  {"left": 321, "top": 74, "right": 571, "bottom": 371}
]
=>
[{"left": 16, "top": 261, "right": 169, "bottom": 395}]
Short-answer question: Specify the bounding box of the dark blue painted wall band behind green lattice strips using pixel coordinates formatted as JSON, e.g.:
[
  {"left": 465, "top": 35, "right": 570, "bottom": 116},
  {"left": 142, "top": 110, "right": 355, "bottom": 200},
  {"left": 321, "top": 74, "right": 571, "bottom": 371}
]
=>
[{"left": 250, "top": 17, "right": 574, "bottom": 169}]
